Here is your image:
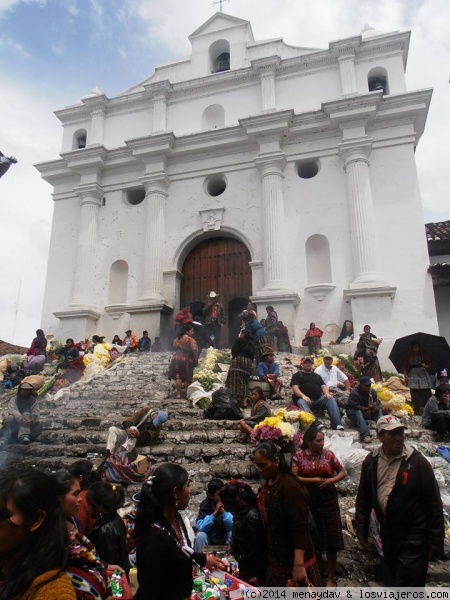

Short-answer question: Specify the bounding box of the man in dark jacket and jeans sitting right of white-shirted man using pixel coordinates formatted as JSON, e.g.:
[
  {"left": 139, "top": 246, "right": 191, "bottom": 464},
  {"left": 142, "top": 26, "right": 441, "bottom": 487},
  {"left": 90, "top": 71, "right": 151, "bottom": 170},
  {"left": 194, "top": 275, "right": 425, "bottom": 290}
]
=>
[{"left": 347, "top": 375, "right": 383, "bottom": 444}]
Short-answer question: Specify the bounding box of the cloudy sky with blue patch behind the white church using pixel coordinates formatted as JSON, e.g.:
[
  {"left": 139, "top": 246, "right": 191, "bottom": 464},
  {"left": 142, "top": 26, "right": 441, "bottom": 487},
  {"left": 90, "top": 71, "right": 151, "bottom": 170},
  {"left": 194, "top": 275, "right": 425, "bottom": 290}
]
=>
[{"left": 0, "top": 0, "right": 450, "bottom": 345}]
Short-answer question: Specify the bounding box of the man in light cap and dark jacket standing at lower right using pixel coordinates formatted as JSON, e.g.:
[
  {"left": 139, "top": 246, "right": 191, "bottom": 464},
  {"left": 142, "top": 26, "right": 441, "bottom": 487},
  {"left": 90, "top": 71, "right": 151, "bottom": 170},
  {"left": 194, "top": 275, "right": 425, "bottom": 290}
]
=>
[{"left": 355, "top": 415, "right": 444, "bottom": 587}]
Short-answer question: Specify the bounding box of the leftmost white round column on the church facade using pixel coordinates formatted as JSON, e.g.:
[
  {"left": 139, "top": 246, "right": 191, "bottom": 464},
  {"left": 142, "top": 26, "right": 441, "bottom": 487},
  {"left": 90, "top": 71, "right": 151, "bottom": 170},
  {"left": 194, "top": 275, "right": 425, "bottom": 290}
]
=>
[{"left": 71, "top": 184, "right": 103, "bottom": 306}]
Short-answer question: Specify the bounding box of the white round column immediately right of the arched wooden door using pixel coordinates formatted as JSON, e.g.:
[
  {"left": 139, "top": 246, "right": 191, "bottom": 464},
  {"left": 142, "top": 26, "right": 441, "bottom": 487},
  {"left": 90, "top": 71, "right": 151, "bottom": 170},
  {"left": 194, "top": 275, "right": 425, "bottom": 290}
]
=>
[{"left": 256, "top": 154, "right": 286, "bottom": 291}]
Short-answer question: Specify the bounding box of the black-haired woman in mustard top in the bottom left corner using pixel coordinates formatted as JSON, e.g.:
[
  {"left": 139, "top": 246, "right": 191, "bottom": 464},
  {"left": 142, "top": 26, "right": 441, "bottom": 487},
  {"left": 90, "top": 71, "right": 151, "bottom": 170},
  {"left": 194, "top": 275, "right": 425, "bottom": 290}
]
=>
[{"left": 0, "top": 469, "right": 75, "bottom": 600}]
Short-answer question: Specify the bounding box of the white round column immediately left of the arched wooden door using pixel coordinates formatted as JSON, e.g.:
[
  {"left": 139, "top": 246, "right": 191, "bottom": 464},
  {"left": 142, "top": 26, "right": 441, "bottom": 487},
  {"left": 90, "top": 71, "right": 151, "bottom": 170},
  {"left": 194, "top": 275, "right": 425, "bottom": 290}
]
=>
[{"left": 140, "top": 173, "right": 170, "bottom": 301}]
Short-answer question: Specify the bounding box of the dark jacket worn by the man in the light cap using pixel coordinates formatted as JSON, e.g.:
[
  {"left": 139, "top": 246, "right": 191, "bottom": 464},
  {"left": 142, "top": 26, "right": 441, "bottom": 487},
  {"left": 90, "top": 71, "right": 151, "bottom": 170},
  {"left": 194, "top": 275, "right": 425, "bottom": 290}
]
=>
[{"left": 355, "top": 448, "right": 444, "bottom": 555}]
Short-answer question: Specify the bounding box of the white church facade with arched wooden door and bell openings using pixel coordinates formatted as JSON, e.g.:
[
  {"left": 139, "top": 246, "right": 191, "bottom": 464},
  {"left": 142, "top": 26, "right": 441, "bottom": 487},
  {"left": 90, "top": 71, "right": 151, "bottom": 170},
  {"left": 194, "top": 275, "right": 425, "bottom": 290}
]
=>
[{"left": 37, "top": 13, "right": 438, "bottom": 360}]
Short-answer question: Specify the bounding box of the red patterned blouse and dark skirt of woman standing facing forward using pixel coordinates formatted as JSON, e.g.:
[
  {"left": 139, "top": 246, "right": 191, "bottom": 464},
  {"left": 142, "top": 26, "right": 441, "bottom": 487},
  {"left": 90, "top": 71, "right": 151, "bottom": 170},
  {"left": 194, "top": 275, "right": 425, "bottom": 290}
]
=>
[{"left": 291, "top": 450, "right": 344, "bottom": 552}]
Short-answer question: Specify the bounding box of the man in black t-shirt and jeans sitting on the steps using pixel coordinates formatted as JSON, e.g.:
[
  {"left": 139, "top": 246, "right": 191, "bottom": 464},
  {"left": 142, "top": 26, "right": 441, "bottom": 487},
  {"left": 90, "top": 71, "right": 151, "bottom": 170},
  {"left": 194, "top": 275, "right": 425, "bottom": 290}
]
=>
[{"left": 291, "top": 356, "right": 344, "bottom": 430}]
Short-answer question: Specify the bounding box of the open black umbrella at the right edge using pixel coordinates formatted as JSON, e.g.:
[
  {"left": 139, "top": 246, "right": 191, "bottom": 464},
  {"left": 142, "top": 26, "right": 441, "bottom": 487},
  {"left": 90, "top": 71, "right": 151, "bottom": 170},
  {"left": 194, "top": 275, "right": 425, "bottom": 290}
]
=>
[{"left": 389, "top": 331, "right": 450, "bottom": 373}]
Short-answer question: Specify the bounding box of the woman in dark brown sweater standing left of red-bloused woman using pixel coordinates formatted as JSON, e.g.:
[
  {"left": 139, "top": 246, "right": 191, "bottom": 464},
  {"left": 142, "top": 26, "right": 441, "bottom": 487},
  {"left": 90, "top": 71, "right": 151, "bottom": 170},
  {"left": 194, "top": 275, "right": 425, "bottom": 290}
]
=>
[{"left": 253, "top": 442, "right": 321, "bottom": 587}]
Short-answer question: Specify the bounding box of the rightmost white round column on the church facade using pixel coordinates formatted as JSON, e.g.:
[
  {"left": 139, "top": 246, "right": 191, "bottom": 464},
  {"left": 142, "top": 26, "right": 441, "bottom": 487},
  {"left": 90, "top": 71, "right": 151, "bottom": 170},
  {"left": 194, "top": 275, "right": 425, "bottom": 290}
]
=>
[{"left": 339, "top": 141, "right": 381, "bottom": 287}]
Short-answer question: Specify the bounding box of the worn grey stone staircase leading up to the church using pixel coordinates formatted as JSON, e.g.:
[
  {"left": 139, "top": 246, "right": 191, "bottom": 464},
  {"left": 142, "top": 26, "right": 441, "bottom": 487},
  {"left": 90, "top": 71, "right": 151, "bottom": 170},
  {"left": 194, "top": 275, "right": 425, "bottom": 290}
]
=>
[{"left": 0, "top": 353, "right": 450, "bottom": 585}]
